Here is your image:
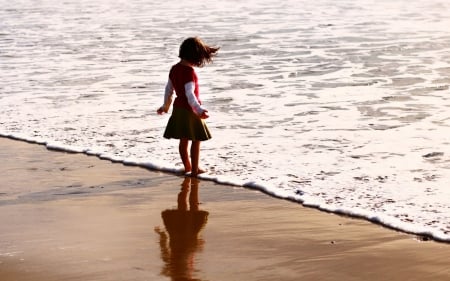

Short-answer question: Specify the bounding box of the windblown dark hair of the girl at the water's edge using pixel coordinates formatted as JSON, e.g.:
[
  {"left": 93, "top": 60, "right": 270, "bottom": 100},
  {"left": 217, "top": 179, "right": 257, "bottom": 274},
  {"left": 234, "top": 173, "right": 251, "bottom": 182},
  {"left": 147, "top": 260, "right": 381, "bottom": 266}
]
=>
[{"left": 178, "top": 37, "right": 219, "bottom": 67}]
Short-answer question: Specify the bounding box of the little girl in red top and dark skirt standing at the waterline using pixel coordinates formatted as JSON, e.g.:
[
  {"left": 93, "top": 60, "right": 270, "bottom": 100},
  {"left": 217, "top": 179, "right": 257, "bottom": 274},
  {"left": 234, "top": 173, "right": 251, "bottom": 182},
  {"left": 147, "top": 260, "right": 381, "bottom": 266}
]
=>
[{"left": 157, "top": 37, "right": 219, "bottom": 177}]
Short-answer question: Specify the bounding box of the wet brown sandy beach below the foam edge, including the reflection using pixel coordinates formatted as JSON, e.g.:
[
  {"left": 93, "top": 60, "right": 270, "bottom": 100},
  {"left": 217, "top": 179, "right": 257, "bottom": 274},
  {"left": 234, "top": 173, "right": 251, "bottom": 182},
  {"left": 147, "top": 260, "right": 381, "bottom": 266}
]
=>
[{"left": 0, "top": 138, "right": 450, "bottom": 281}]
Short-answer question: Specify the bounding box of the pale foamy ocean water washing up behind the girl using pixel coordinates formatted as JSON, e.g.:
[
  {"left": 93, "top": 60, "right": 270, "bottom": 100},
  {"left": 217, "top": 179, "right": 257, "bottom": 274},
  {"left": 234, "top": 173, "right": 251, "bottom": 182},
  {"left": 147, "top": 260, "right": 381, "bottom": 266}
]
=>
[{"left": 0, "top": 0, "right": 450, "bottom": 241}]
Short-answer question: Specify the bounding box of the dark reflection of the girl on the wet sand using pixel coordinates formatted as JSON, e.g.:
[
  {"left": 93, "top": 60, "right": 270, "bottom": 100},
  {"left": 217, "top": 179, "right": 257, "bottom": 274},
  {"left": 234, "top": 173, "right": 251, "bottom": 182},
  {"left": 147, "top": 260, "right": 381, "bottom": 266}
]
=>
[{"left": 155, "top": 177, "right": 208, "bottom": 280}]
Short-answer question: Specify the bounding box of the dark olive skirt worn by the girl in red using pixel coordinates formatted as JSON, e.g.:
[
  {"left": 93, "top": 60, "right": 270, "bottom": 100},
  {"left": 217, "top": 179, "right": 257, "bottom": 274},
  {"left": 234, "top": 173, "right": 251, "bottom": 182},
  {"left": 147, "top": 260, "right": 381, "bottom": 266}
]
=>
[{"left": 164, "top": 106, "right": 211, "bottom": 141}]
